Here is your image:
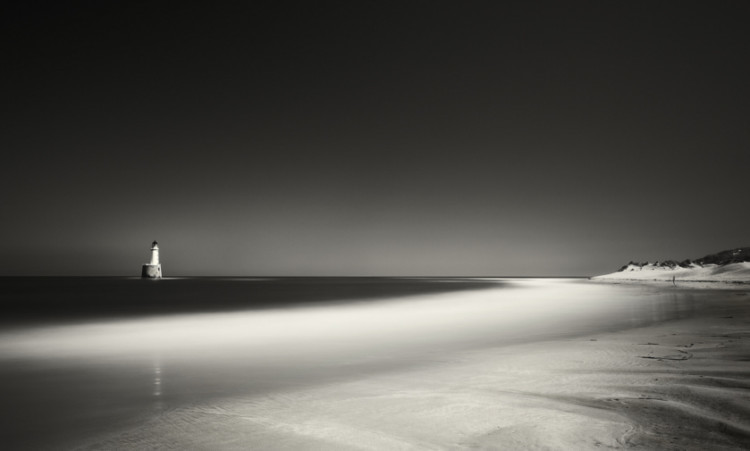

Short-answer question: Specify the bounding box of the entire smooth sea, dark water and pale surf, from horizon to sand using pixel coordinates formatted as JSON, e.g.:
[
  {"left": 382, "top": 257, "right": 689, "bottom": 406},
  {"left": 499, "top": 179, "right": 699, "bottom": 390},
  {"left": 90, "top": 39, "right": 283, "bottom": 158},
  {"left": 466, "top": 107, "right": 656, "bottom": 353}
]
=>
[{"left": 0, "top": 277, "right": 740, "bottom": 449}]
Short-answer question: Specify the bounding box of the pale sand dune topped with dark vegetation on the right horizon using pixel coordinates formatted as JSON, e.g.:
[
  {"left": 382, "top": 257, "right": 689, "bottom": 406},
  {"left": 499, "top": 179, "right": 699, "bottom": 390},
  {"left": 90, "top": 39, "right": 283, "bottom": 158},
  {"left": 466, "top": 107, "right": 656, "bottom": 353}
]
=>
[{"left": 592, "top": 247, "right": 750, "bottom": 283}]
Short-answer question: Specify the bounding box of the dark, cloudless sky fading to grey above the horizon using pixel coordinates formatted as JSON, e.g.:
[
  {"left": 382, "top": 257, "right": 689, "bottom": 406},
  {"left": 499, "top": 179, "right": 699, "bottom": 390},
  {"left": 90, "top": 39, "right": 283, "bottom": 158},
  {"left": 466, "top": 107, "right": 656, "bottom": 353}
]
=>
[{"left": 0, "top": 1, "right": 750, "bottom": 275}]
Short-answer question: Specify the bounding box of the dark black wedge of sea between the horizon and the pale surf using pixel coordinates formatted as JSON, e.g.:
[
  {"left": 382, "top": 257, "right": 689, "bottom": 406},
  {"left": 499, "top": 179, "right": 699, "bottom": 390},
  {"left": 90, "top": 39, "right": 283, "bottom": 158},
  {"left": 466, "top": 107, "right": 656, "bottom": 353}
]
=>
[{"left": 0, "top": 277, "right": 506, "bottom": 326}]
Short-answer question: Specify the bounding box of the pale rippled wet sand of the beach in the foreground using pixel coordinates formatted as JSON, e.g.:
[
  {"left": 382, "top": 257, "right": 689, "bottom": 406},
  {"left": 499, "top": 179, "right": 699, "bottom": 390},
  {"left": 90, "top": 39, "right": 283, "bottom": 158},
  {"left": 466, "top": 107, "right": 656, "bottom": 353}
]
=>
[{"left": 72, "top": 292, "right": 750, "bottom": 450}]
